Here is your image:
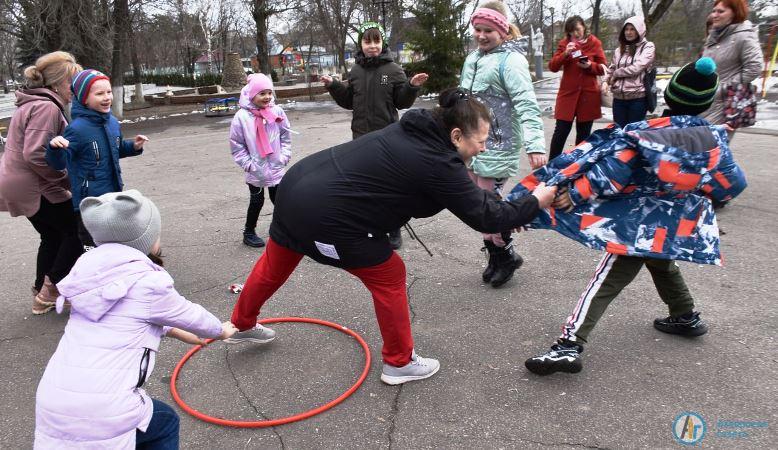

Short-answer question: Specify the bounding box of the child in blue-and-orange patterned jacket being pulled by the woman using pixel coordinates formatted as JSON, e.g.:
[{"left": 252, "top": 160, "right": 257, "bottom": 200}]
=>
[{"left": 508, "top": 58, "right": 746, "bottom": 375}]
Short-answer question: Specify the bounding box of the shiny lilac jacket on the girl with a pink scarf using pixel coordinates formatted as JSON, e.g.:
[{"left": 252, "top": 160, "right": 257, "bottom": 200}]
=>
[{"left": 230, "top": 95, "right": 292, "bottom": 187}]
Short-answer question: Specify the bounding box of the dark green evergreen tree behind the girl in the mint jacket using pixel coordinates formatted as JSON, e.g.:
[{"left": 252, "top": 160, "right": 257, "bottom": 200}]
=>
[{"left": 406, "top": 0, "right": 467, "bottom": 92}]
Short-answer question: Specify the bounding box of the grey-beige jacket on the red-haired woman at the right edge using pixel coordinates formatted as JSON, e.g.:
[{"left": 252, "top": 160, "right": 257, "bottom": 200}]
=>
[{"left": 702, "top": 20, "right": 763, "bottom": 125}]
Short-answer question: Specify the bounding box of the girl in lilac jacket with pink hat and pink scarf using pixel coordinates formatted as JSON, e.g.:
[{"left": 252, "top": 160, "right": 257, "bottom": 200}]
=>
[{"left": 230, "top": 73, "right": 292, "bottom": 247}]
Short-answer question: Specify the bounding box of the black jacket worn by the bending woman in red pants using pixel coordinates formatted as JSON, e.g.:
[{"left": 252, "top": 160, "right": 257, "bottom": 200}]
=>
[{"left": 270, "top": 109, "right": 539, "bottom": 268}]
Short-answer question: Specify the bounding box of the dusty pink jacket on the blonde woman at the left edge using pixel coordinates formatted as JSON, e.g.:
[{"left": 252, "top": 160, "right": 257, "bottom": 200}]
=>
[{"left": 0, "top": 88, "right": 71, "bottom": 217}]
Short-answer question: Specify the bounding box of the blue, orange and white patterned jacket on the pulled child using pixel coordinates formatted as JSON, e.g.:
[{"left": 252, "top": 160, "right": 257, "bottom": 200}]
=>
[{"left": 507, "top": 116, "right": 746, "bottom": 265}]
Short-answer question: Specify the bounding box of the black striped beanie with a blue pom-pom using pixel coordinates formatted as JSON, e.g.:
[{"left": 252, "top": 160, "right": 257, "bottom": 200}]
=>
[{"left": 665, "top": 57, "right": 719, "bottom": 116}]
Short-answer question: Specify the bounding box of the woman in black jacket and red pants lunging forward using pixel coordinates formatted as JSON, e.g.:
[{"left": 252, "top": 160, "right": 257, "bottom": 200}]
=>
[{"left": 224, "top": 90, "right": 555, "bottom": 384}]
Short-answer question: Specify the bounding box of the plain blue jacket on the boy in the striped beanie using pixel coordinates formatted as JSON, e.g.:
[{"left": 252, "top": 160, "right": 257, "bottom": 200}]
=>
[{"left": 46, "top": 102, "right": 143, "bottom": 211}]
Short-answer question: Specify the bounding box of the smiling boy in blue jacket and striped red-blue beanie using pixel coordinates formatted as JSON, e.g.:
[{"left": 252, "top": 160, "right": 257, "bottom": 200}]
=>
[{"left": 46, "top": 69, "right": 148, "bottom": 250}]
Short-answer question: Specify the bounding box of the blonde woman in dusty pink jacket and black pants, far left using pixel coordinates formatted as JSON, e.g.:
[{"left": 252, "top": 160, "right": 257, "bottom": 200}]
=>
[{"left": 0, "top": 52, "right": 82, "bottom": 314}]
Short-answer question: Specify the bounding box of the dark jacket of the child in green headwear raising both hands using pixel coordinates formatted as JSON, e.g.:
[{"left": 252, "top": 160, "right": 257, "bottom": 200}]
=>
[{"left": 327, "top": 49, "right": 419, "bottom": 139}]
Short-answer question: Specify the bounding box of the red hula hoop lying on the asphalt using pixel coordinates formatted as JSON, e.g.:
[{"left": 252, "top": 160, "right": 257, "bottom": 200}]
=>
[{"left": 170, "top": 317, "right": 370, "bottom": 428}]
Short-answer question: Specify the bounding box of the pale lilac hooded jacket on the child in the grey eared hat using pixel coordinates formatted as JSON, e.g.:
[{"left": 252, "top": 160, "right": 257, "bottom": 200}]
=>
[{"left": 34, "top": 244, "right": 222, "bottom": 449}]
